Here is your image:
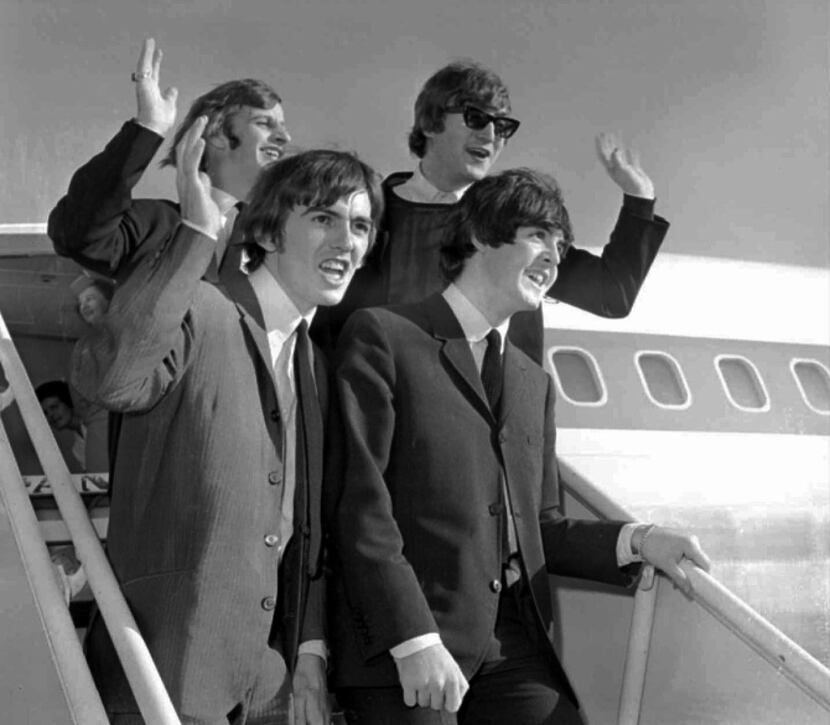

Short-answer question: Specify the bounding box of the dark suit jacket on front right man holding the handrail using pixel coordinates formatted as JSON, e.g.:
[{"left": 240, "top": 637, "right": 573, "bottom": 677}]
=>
[{"left": 332, "top": 295, "right": 630, "bottom": 686}]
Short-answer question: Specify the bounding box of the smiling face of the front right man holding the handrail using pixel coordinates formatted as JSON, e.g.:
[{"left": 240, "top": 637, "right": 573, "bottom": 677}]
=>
[{"left": 478, "top": 227, "right": 565, "bottom": 317}]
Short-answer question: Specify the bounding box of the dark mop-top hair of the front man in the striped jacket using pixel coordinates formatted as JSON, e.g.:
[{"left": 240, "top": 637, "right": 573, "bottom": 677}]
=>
[{"left": 240, "top": 149, "right": 383, "bottom": 270}]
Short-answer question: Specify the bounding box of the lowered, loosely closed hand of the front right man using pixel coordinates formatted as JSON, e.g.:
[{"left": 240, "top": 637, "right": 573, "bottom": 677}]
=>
[{"left": 395, "top": 644, "right": 470, "bottom": 712}]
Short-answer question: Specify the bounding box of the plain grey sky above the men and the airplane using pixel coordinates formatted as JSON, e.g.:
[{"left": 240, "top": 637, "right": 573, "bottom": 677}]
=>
[{"left": 0, "top": 0, "right": 830, "bottom": 268}]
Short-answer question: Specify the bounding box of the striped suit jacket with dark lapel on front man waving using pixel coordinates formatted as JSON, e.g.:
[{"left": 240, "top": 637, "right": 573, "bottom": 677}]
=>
[{"left": 73, "top": 225, "right": 326, "bottom": 717}]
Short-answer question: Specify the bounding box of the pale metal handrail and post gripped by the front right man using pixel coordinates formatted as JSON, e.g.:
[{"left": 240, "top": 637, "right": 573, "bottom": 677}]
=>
[{"left": 559, "top": 460, "right": 830, "bottom": 725}]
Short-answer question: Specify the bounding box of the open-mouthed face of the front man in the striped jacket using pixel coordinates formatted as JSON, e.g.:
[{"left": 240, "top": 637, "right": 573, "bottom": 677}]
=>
[{"left": 265, "top": 190, "right": 373, "bottom": 314}]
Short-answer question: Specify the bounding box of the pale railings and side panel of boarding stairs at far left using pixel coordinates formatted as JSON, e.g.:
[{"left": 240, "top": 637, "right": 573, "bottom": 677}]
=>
[{"left": 0, "top": 316, "right": 179, "bottom": 725}]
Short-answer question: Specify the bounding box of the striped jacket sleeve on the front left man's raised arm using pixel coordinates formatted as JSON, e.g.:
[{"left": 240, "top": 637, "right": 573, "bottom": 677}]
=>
[{"left": 71, "top": 224, "right": 215, "bottom": 412}]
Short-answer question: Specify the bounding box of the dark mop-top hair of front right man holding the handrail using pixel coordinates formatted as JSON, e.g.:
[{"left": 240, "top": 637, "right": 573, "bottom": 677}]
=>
[{"left": 441, "top": 168, "right": 573, "bottom": 282}]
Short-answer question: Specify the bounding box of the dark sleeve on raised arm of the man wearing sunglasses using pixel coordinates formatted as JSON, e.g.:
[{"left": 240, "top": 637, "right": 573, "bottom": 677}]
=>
[{"left": 548, "top": 195, "right": 669, "bottom": 317}]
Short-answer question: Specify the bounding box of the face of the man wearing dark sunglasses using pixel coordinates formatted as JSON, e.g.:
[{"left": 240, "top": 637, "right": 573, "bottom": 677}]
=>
[{"left": 424, "top": 106, "right": 507, "bottom": 188}]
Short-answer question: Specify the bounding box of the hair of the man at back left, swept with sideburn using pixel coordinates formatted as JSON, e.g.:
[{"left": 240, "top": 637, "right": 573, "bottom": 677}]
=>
[{"left": 160, "top": 78, "right": 282, "bottom": 171}]
